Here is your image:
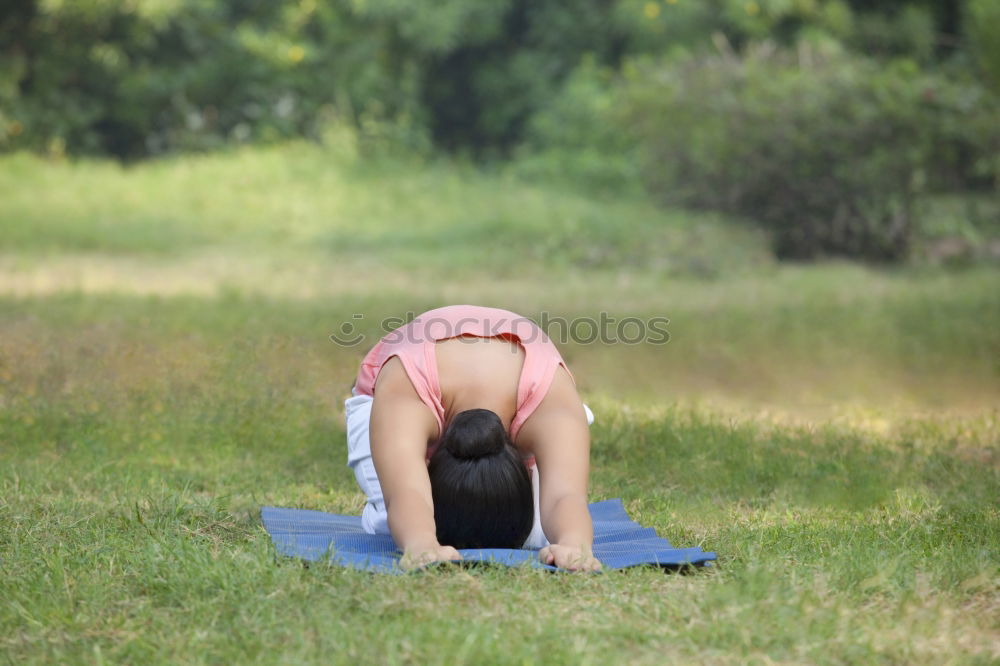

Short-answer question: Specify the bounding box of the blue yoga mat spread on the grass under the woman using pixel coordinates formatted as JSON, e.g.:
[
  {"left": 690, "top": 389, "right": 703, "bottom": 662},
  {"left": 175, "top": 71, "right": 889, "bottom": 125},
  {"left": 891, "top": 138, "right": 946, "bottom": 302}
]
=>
[{"left": 260, "top": 499, "right": 715, "bottom": 573}]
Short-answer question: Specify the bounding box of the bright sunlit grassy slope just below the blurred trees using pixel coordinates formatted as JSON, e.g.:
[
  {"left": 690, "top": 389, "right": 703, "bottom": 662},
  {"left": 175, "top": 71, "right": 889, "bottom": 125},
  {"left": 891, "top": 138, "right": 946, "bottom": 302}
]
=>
[{"left": 0, "top": 145, "right": 770, "bottom": 275}]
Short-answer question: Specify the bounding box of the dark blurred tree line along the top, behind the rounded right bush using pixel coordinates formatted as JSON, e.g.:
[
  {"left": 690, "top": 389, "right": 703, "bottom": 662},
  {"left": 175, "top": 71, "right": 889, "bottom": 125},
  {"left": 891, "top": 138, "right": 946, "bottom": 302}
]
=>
[{"left": 0, "top": 0, "right": 998, "bottom": 158}]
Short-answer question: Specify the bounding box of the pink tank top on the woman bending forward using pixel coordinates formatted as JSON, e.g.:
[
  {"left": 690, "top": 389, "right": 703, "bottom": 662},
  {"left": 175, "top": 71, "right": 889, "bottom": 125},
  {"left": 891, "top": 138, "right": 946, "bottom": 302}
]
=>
[{"left": 355, "top": 305, "right": 573, "bottom": 458}]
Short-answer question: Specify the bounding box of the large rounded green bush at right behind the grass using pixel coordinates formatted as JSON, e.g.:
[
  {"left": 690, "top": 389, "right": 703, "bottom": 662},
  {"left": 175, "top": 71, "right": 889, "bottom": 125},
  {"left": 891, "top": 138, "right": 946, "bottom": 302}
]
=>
[{"left": 625, "top": 46, "right": 996, "bottom": 260}]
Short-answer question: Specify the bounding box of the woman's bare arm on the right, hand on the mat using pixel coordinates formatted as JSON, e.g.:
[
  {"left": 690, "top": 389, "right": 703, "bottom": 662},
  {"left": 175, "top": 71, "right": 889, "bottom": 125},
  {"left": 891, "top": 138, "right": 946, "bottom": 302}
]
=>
[{"left": 518, "top": 370, "right": 600, "bottom": 570}]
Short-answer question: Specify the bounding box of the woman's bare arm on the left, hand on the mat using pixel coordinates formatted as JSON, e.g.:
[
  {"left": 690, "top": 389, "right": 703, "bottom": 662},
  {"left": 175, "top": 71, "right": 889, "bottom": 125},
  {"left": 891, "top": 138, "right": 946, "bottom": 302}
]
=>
[{"left": 370, "top": 359, "right": 459, "bottom": 567}]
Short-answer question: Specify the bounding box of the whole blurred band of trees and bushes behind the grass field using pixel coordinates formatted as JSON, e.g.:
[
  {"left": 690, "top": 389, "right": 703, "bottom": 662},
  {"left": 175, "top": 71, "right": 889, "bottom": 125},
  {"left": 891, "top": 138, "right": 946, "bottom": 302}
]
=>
[{"left": 0, "top": 0, "right": 1000, "bottom": 260}]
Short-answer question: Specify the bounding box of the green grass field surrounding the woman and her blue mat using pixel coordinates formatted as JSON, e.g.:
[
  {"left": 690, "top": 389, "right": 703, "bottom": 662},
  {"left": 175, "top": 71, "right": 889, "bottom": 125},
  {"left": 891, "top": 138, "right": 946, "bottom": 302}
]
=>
[{"left": 0, "top": 145, "right": 1000, "bottom": 664}]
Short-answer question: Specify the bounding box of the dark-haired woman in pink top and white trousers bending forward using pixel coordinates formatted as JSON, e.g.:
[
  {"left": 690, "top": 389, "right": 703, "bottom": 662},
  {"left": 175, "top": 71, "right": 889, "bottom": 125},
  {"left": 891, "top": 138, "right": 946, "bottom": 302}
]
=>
[{"left": 345, "top": 305, "right": 600, "bottom": 571}]
